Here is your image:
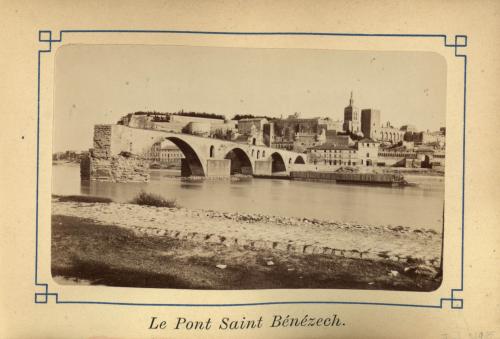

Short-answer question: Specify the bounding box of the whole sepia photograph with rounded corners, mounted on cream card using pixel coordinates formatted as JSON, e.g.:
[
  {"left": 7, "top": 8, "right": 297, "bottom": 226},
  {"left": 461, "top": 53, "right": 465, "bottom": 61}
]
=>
[{"left": 51, "top": 44, "right": 447, "bottom": 292}]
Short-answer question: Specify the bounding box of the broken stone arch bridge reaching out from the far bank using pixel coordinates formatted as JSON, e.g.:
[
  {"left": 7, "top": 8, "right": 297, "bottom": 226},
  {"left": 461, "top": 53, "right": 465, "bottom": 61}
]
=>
[{"left": 90, "top": 125, "right": 306, "bottom": 181}]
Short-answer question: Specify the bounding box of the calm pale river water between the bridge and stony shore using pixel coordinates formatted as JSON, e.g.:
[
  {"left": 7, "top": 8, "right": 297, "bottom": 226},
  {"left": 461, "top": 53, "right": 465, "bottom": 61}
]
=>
[{"left": 52, "top": 164, "right": 444, "bottom": 231}]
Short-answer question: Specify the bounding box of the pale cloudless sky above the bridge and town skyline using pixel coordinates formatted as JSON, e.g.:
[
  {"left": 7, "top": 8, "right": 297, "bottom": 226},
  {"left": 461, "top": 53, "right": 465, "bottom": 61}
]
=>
[{"left": 54, "top": 45, "right": 446, "bottom": 152}]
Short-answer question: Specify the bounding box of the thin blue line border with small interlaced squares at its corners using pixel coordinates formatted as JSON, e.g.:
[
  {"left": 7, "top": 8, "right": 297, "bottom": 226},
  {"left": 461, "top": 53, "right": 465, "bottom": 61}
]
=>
[{"left": 35, "top": 30, "right": 467, "bottom": 309}]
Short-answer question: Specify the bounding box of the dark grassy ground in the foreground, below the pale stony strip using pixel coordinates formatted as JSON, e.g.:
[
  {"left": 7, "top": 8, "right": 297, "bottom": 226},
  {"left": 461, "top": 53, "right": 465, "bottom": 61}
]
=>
[{"left": 52, "top": 215, "right": 440, "bottom": 291}]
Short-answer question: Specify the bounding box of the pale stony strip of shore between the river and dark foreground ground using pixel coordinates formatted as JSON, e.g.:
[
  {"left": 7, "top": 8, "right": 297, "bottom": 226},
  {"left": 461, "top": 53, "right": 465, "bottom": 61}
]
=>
[{"left": 52, "top": 199, "right": 441, "bottom": 265}]
